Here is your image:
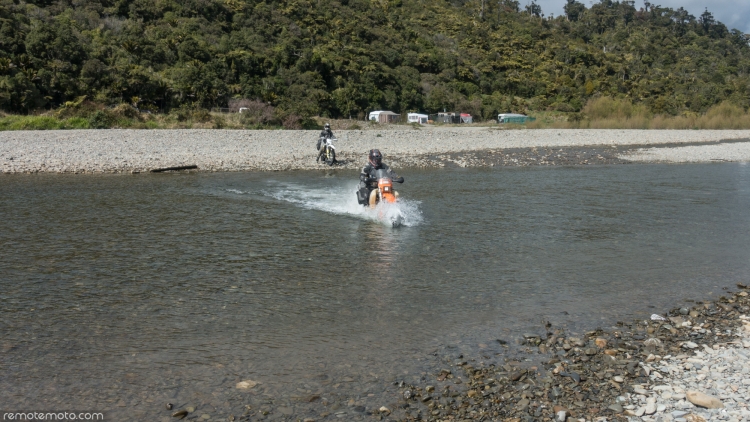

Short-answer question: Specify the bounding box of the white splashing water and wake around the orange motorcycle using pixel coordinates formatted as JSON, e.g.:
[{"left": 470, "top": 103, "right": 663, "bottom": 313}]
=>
[{"left": 263, "top": 183, "right": 422, "bottom": 227}]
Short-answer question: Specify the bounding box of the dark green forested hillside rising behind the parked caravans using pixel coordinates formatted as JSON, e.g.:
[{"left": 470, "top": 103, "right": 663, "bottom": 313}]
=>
[{"left": 0, "top": 0, "right": 750, "bottom": 119}]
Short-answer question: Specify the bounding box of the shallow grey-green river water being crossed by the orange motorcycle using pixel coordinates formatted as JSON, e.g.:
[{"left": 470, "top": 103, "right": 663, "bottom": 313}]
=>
[{"left": 0, "top": 164, "right": 750, "bottom": 420}]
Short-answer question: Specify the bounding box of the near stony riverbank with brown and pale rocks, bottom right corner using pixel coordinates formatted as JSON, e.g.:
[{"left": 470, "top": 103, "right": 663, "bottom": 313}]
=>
[{"left": 380, "top": 285, "right": 750, "bottom": 422}]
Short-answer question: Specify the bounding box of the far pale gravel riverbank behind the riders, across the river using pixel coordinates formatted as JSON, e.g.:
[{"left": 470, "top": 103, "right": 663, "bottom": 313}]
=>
[{"left": 0, "top": 126, "right": 750, "bottom": 173}]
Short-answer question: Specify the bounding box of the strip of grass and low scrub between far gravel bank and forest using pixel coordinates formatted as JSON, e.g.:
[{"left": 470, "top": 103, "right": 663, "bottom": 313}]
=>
[{"left": 0, "top": 97, "right": 750, "bottom": 130}]
